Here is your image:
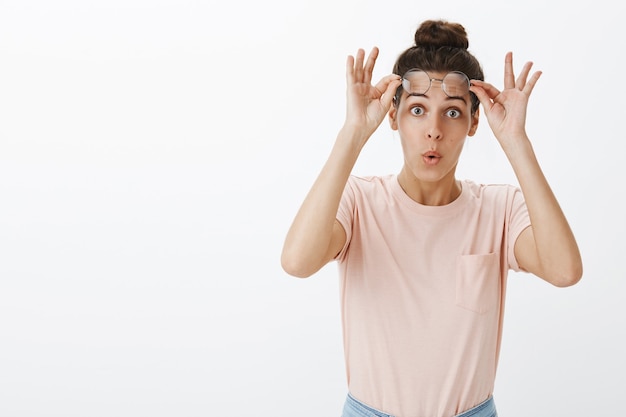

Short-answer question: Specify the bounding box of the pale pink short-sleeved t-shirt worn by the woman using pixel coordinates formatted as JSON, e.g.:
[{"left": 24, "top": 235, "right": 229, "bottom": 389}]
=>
[{"left": 337, "top": 175, "right": 530, "bottom": 417}]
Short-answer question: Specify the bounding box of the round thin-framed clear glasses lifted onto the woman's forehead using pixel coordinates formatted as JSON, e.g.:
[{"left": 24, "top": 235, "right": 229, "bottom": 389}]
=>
[{"left": 402, "top": 68, "right": 470, "bottom": 98}]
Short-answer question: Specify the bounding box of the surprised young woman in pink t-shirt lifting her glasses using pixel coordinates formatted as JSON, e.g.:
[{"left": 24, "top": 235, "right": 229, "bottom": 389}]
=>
[{"left": 281, "top": 21, "right": 582, "bottom": 417}]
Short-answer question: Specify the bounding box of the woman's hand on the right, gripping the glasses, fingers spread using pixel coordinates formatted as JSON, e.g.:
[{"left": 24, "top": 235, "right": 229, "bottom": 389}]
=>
[{"left": 470, "top": 52, "right": 541, "bottom": 150}]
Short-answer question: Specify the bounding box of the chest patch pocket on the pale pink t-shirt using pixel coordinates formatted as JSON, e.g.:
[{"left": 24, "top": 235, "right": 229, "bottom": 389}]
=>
[{"left": 455, "top": 252, "right": 500, "bottom": 314}]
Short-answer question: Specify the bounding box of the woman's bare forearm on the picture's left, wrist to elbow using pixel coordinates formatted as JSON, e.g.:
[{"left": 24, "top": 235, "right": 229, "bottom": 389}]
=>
[{"left": 281, "top": 128, "right": 365, "bottom": 276}]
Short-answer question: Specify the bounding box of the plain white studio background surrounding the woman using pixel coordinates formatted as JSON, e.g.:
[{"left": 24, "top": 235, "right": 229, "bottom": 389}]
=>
[{"left": 0, "top": 0, "right": 626, "bottom": 417}]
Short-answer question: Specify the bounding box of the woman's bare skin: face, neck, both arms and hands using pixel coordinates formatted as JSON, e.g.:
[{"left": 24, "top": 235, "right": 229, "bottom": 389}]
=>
[{"left": 281, "top": 48, "right": 582, "bottom": 287}]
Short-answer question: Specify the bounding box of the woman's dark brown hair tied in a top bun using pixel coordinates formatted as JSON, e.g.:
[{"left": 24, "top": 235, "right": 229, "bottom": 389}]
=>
[{"left": 393, "top": 20, "right": 485, "bottom": 114}]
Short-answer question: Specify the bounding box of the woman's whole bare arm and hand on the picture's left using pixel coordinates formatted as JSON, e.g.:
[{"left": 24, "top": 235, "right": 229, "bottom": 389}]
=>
[{"left": 281, "top": 48, "right": 400, "bottom": 278}]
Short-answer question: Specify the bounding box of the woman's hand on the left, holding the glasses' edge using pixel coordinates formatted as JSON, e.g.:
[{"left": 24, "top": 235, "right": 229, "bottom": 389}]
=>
[{"left": 345, "top": 47, "right": 402, "bottom": 141}]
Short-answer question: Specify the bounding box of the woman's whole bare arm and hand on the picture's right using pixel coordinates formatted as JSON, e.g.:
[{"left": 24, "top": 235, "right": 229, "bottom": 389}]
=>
[{"left": 471, "top": 52, "right": 583, "bottom": 287}]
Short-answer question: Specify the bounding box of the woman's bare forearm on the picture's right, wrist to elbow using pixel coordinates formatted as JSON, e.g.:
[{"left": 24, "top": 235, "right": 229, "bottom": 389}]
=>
[{"left": 505, "top": 137, "right": 582, "bottom": 285}]
